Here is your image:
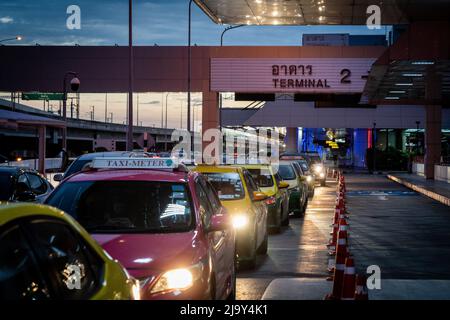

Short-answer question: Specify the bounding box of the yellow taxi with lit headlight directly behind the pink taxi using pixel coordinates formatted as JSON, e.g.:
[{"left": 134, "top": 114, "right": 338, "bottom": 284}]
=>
[{"left": 194, "top": 165, "right": 268, "bottom": 268}]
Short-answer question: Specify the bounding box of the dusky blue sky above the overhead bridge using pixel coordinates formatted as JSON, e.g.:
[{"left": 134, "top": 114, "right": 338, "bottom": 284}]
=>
[{"left": 0, "top": 0, "right": 385, "bottom": 45}]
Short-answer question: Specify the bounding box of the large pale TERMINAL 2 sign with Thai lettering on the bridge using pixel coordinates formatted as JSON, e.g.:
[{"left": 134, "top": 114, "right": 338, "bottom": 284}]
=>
[{"left": 211, "top": 58, "right": 375, "bottom": 93}]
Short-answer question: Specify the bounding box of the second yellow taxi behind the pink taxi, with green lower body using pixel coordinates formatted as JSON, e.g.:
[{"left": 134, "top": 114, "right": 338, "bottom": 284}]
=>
[{"left": 241, "top": 164, "right": 289, "bottom": 233}]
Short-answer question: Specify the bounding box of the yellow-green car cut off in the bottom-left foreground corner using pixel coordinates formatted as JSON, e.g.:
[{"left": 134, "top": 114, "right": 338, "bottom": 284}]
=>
[{"left": 0, "top": 202, "right": 139, "bottom": 300}]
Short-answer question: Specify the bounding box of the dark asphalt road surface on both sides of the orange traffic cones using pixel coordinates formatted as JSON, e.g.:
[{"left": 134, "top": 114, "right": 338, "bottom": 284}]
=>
[{"left": 237, "top": 174, "right": 450, "bottom": 299}]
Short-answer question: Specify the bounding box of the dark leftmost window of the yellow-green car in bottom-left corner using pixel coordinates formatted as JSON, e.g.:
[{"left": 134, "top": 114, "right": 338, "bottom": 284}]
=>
[{"left": 0, "top": 225, "right": 51, "bottom": 300}]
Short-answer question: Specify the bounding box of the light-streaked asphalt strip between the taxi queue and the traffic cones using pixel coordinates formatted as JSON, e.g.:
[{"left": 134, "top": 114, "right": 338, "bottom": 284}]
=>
[{"left": 237, "top": 181, "right": 336, "bottom": 300}]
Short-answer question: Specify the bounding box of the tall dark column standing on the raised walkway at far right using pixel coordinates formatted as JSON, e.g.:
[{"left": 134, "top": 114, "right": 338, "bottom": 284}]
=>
[{"left": 424, "top": 66, "right": 442, "bottom": 179}]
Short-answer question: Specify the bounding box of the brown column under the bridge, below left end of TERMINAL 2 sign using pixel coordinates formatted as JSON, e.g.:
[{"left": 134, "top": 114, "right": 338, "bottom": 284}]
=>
[{"left": 202, "top": 91, "right": 222, "bottom": 162}]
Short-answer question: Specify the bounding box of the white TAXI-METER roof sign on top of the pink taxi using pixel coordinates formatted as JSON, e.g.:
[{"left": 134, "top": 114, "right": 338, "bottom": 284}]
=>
[{"left": 91, "top": 157, "right": 178, "bottom": 169}]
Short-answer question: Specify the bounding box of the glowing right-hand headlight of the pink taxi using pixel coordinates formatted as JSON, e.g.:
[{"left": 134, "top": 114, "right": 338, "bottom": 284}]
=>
[{"left": 150, "top": 263, "right": 203, "bottom": 293}]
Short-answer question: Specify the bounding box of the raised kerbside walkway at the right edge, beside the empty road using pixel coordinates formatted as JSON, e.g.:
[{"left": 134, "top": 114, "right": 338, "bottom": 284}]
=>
[{"left": 387, "top": 173, "right": 450, "bottom": 206}]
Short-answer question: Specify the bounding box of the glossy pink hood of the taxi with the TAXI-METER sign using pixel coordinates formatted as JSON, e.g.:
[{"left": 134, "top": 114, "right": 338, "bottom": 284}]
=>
[{"left": 93, "top": 231, "right": 199, "bottom": 277}]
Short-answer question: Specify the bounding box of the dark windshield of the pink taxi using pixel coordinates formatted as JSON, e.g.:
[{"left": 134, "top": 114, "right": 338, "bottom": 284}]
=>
[{"left": 46, "top": 181, "right": 194, "bottom": 233}]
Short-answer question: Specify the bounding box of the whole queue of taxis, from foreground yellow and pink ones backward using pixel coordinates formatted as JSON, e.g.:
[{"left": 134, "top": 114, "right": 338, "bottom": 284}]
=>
[{"left": 0, "top": 153, "right": 324, "bottom": 299}]
